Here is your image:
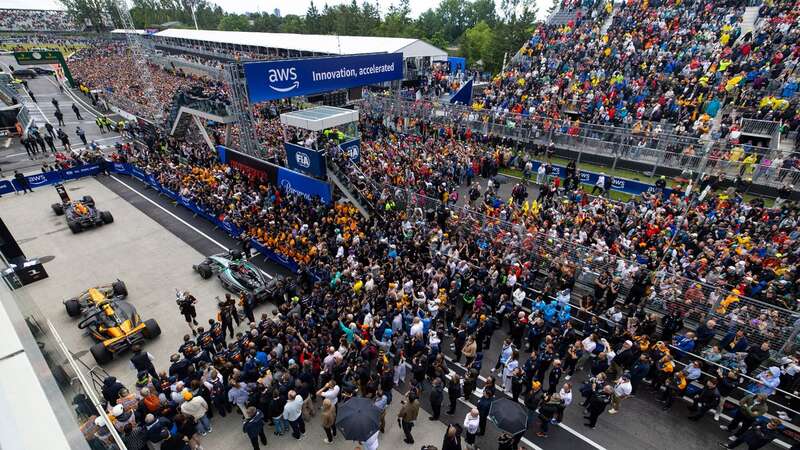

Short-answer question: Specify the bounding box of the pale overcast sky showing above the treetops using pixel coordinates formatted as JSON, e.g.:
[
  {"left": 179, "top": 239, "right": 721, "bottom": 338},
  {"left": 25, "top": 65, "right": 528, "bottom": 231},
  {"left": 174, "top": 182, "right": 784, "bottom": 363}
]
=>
[{"left": 0, "top": 0, "right": 553, "bottom": 17}]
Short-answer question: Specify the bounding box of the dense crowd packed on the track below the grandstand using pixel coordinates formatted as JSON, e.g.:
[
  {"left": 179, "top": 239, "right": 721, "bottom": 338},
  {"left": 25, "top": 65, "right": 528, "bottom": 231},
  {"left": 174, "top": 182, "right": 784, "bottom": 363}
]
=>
[{"left": 78, "top": 110, "right": 800, "bottom": 448}]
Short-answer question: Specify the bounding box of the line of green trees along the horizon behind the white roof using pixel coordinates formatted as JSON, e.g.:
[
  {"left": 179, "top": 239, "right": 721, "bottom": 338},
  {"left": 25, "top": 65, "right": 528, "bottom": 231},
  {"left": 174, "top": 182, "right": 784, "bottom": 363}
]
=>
[{"left": 60, "top": 0, "right": 537, "bottom": 72}]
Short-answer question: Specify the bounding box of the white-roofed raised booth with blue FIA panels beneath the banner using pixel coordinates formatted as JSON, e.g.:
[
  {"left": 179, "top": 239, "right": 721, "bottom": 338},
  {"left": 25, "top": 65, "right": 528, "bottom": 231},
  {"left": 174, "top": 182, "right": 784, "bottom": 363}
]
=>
[{"left": 281, "top": 106, "right": 361, "bottom": 179}]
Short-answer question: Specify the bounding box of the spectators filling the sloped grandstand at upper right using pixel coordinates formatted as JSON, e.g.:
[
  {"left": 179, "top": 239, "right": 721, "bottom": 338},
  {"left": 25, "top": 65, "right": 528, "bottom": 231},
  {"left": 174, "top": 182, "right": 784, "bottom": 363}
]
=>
[{"left": 440, "top": 1, "right": 800, "bottom": 183}]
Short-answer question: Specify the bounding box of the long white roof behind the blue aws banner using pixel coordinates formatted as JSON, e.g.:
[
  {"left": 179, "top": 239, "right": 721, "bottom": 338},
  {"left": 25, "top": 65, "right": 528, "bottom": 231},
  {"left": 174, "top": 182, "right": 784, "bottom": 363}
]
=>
[{"left": 155, "top": 28, "right": 447, "bottom": 61}]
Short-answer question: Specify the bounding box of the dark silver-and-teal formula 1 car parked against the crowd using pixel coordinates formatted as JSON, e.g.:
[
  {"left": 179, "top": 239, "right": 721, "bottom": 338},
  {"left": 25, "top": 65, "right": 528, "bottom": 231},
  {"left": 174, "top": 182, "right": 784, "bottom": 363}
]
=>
[{"left": 192, "top": 250, "right": 280, "bottom": 302}]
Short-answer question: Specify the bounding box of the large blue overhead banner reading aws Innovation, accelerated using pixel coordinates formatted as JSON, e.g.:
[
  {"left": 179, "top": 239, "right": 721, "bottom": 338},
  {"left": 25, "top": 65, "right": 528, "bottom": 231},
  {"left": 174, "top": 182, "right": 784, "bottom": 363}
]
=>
[{"left": 244, "top": 53, "right": 403, "bottom": 103}]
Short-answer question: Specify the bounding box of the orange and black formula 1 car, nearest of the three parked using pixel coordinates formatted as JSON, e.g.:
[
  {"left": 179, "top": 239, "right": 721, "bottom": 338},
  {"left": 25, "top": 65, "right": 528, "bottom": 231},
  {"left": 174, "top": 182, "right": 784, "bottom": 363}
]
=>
[{"left": 64, "top": 280, "right": 161, "bottom": 364}]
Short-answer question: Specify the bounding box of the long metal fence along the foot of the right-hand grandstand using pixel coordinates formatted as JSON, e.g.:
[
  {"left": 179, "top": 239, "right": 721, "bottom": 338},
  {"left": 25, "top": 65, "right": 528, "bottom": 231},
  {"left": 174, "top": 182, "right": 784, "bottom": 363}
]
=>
[{"left": 361, "top": 95, "right": 800, "bottom": 187}]
